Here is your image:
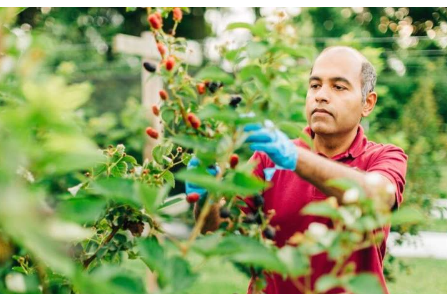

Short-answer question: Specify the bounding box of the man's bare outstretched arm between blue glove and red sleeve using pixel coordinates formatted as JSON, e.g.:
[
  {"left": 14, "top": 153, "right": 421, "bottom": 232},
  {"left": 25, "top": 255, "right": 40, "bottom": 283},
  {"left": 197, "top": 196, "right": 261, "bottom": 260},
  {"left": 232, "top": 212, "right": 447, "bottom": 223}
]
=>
[{"left": 295, "top": 147, "right": 396, "bottom": 208}]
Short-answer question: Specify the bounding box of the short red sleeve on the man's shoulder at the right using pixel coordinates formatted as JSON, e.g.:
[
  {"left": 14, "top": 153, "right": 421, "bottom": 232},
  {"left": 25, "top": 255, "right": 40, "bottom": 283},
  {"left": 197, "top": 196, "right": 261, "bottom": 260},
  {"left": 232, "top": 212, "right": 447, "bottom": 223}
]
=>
[{"left": 367, "top": 144, "right": 408, "bottom": 209}]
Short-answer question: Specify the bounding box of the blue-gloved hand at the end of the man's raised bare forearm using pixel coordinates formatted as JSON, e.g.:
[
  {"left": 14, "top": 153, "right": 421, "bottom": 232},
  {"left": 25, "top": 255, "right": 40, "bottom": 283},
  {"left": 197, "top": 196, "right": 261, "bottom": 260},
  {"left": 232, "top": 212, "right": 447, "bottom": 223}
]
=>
[{"left": 244, "top": 121, "right": 298, "bottom": 180}]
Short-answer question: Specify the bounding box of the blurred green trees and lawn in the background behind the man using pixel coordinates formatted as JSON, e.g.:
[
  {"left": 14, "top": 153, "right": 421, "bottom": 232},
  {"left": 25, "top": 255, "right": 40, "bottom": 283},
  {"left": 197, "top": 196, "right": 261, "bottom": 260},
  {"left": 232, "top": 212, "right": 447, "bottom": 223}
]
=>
[{"left": 0, "top": 7, "right": 447, "bottom": 293}]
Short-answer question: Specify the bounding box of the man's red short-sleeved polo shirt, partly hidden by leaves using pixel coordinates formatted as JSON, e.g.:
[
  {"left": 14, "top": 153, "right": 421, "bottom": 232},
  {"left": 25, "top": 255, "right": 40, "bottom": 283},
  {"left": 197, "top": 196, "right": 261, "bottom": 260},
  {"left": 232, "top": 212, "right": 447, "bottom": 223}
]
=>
[{"left": 246, "top": 125, "right": 407, "bottom": 294}]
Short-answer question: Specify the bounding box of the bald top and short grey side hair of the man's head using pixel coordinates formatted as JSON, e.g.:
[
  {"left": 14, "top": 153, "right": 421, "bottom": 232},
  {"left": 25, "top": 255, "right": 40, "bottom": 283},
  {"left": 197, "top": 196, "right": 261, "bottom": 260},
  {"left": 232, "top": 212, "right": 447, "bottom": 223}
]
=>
[{"left": 311, "top": 46, "right": 377, "bottom": 103}]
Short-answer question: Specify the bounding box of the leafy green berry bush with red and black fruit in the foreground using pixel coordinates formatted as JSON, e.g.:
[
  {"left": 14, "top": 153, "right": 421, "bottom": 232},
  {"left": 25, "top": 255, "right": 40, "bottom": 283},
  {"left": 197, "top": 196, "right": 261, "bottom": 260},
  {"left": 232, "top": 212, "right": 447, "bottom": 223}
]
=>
[{"left": 0, "top": 8, "right": 419, "bottom": 294}]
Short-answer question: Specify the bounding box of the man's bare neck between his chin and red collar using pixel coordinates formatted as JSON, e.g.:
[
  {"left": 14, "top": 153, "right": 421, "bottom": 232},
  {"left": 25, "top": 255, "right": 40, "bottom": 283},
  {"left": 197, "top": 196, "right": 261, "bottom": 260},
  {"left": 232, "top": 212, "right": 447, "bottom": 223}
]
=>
[{"left": 313, "top": 127, "right": 358, "bottom": 158}]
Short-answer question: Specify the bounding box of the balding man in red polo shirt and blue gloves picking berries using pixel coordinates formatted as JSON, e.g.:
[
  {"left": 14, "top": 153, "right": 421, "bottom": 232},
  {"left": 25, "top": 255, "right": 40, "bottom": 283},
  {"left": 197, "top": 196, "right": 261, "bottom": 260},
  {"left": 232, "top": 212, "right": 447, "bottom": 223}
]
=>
[{"left": 187, "top": 47, "right": 407, "bottom": 294}]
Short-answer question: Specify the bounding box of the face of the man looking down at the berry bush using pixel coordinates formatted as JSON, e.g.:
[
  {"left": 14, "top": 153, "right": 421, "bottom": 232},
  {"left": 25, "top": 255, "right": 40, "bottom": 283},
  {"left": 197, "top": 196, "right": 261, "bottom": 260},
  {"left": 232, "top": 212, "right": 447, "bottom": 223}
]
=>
[{"left": 306, "top": 49, "right": 362, "bottom": 135}]
